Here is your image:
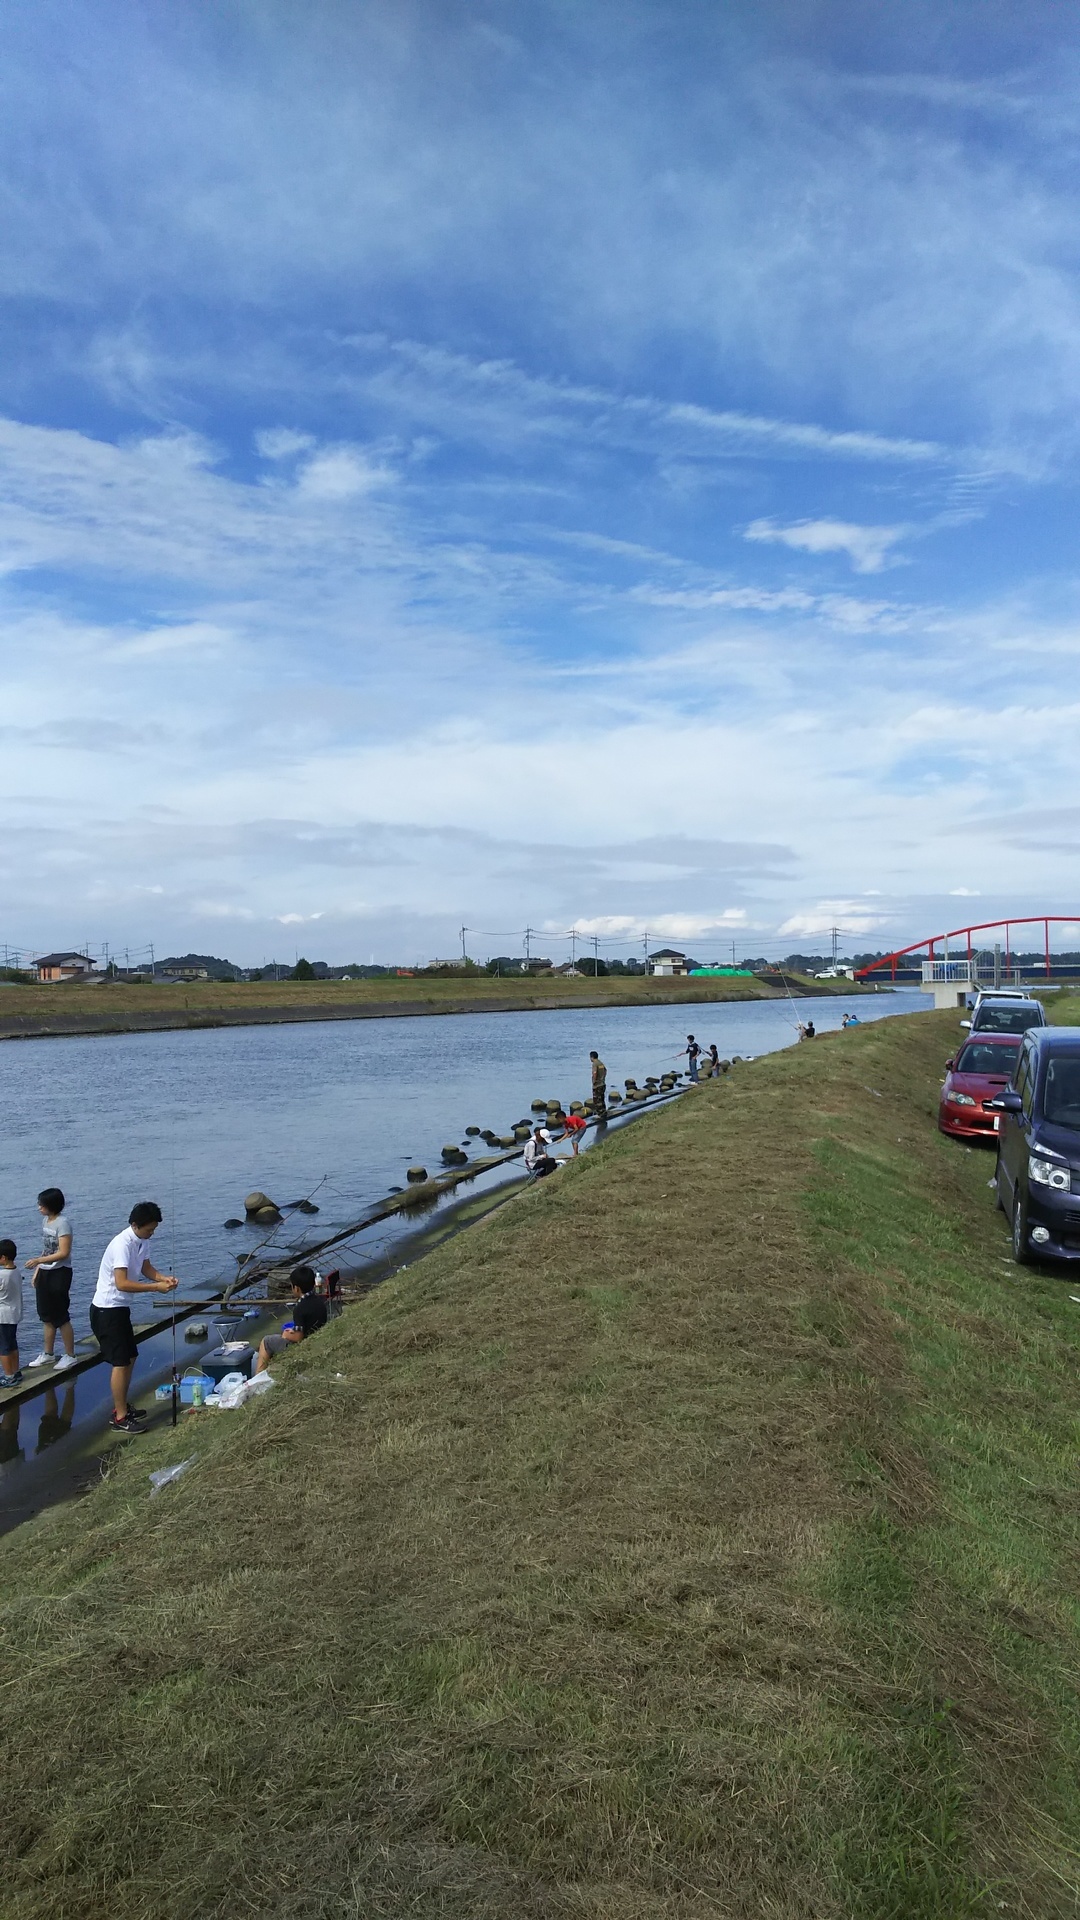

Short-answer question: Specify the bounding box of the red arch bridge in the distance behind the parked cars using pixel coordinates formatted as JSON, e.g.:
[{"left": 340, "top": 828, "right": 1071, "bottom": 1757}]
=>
[{"left": 855, "top": 914, "right": 1080, "bottom": 1006}]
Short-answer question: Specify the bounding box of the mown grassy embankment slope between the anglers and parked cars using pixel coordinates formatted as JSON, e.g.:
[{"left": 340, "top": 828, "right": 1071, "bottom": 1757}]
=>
[{"left": 2, "top": 1008, "right": 1080, "bottom": 1920}]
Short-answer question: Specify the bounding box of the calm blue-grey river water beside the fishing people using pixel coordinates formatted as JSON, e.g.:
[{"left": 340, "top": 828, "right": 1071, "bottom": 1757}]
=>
[{"left": 0, "top": 991, "right": 914, "bottom": 1526}]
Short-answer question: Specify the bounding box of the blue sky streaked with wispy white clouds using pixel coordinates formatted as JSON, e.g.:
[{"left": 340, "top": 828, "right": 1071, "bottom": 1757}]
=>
[{"left": 0, "top": 0, "right": 1080, "bottom": 962}]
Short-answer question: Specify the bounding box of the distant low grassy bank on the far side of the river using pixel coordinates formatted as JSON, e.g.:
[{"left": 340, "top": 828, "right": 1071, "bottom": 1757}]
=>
[{"left": 0, "top": 973, "right": 863, "bottom": 1039}]
